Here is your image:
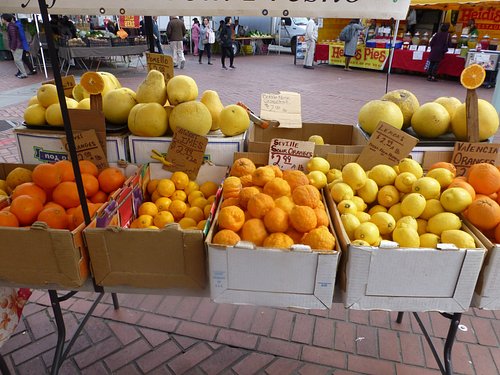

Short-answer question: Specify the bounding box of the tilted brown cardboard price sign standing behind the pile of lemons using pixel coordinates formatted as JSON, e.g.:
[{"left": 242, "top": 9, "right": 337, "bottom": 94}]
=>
[{"left": 357, "top": 122, "right": 418, "bottom": 170}]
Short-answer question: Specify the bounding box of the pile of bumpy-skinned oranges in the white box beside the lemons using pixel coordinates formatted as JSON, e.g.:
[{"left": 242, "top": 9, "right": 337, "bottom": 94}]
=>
[{"left": 212, "top": 158, "right": 335, "bottom": 251}]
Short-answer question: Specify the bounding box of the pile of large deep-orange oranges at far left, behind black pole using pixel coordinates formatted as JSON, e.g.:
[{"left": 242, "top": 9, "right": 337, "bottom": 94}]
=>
[{"left": 0, "top": 160, "right": 125, "bottom": 230}]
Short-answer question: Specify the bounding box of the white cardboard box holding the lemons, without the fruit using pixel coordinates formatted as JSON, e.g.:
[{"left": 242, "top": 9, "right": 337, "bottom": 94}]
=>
[{"left": 326, "top": 155, "right": 486, "bottom": 313}]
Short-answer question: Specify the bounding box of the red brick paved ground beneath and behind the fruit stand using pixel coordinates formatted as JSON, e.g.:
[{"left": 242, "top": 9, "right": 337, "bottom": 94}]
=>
[{"left": 0, "top": 50, "right": 500, "bottom": 375}]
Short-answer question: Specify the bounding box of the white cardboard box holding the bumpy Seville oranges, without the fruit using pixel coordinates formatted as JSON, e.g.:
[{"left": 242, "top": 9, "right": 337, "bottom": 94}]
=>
[{"left": 206, "top": 153, "right": 340, "bottom": 309}]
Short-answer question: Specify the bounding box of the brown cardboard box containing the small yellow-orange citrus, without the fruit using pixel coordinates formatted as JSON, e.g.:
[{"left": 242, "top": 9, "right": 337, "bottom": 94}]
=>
[{"left": 84, "top": 163, "right": 227, "bottom": 289}]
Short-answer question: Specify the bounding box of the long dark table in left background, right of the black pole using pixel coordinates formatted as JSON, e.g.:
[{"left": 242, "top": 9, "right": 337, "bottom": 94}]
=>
[{"left": 58, "top": 44, "right": 148, "bottom": 74}]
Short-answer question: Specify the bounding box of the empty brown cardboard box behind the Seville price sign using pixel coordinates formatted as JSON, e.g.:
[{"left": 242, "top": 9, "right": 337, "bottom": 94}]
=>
[{"left": 248, "top": 123, "right": 368, "bottom": 157}]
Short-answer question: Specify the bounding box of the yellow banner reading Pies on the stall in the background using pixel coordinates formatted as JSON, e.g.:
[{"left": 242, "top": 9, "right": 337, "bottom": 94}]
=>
[{"left": 328, "top": 44, "right": 390, "bottom": 70}]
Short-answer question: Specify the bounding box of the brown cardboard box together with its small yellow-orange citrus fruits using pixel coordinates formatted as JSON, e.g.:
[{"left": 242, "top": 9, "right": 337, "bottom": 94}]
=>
[{"left": 85, "top": 163, "right": 227, "bottom": 289}]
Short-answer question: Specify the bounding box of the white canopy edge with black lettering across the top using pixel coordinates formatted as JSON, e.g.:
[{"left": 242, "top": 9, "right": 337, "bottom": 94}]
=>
[{"left": 0, "top": 0, "right": 410, "bottom": 20}]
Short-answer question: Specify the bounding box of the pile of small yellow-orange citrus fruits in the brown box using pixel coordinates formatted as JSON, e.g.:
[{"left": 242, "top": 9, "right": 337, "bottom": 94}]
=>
[{"left": 130, "top": 172, "right": 218, "bottom": 230}]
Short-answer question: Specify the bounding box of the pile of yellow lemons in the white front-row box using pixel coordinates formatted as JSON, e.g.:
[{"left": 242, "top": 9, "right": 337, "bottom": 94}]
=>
[{"left": 328, "top": 158, "right": 476, "bottom": 248}]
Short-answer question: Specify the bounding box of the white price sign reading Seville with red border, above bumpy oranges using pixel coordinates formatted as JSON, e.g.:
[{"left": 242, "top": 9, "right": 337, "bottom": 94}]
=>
[{"left": 268, "top": 138, "right": 315, "bottom": 171}]
